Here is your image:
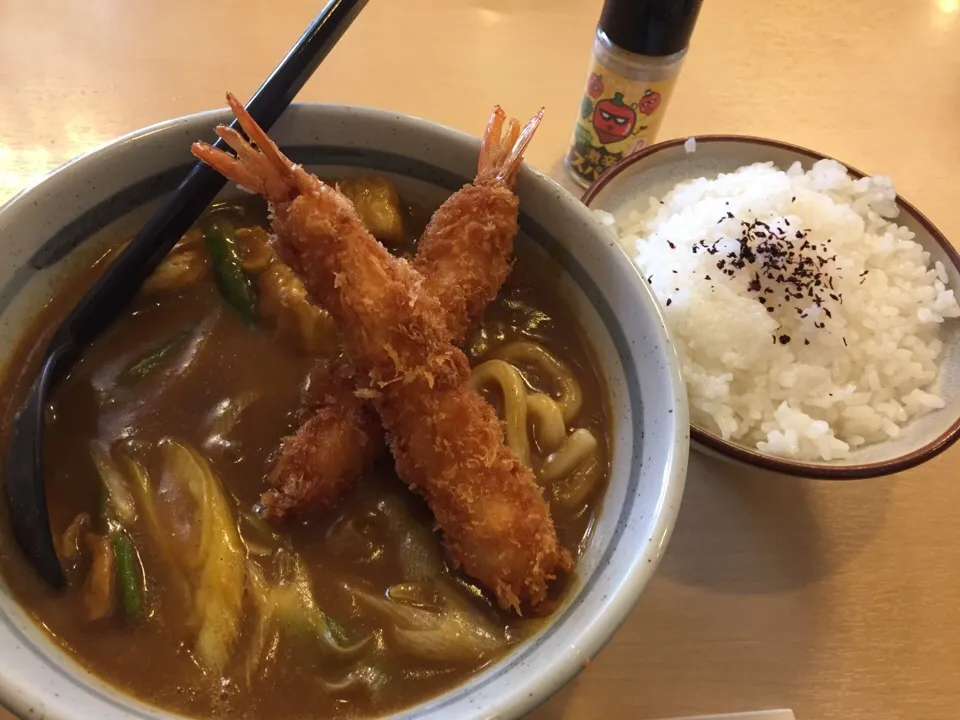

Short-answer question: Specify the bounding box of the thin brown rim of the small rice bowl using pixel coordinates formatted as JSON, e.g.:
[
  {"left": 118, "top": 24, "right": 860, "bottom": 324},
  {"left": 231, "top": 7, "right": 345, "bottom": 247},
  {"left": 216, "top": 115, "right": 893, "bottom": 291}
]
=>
[{"left": 580, "top": 134, "right": 960, "bottom": 480}]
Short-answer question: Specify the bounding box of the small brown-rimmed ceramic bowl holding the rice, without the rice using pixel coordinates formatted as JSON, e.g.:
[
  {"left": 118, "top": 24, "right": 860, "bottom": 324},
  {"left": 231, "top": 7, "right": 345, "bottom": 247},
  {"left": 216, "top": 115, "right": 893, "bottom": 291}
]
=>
[{"left": 583, "top": 135, "right": 960, "bottom": 480}]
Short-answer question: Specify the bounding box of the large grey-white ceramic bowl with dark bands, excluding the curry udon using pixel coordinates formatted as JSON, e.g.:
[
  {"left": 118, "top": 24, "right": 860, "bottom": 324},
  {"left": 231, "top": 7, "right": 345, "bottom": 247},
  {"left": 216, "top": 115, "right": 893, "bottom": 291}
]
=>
[{"left": 0, "top": 105, "right": 688, "bottom": 720}]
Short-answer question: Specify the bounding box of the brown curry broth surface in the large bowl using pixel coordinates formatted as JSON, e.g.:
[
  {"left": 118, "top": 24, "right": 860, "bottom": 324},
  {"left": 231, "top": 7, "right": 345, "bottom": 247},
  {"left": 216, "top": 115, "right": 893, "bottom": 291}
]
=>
[{"left": 0, "top": 194, "right": 609, "bottom": 719}]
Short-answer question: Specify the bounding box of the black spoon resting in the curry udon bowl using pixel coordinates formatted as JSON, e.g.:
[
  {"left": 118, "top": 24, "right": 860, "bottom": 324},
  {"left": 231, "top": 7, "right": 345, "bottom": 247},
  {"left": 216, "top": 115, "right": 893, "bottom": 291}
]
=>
[{"left": 4, "top": 0, "right": 367, "bottom": 588}]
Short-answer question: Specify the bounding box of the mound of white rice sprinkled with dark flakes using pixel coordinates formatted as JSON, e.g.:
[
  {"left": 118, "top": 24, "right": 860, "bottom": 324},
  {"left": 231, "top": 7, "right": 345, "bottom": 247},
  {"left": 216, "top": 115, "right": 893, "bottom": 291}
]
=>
[{"left": 604, "top": 160, "right": 960, "bottom": 460}]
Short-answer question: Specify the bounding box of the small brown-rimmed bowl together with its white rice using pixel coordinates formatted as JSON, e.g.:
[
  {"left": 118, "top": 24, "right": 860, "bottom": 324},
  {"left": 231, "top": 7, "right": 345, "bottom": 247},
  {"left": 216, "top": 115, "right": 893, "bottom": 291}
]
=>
[{"left": 584, "top": 136, "right": 960, "bottom": 477}]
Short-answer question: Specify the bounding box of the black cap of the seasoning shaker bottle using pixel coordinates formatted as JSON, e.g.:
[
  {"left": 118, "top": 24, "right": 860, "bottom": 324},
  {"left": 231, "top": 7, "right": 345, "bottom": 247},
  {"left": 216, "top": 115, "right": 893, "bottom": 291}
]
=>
[{"left": 600, "top": 0, "right": 703, "bottom": 57}]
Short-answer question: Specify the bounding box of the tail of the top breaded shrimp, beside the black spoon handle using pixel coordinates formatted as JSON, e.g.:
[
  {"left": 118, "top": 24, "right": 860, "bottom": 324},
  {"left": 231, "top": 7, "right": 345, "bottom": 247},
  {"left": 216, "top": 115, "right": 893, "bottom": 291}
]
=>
[{"left": 191, "top": 93, "right": 303, "bottom": 202}]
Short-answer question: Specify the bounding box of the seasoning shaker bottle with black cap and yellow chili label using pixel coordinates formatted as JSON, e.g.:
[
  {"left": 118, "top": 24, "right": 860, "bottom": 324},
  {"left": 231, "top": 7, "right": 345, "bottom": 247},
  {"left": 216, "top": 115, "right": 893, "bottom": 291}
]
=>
[{"left": 566, "top": 0, "right": 702, "bottom": 187}]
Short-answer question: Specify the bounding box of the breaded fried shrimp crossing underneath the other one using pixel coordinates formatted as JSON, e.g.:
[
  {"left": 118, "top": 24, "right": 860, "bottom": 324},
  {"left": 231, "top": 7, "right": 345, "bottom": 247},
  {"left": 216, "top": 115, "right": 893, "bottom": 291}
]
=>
[{"left": 261, "top": 106, "right": 543, "bottom": 517}]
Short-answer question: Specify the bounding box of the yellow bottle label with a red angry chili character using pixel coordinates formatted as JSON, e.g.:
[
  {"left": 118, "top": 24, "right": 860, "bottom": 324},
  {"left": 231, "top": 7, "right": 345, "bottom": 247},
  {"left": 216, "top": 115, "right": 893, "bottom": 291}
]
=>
[{"left": 567, "top": 60, "right": 676, "bottom": 184}]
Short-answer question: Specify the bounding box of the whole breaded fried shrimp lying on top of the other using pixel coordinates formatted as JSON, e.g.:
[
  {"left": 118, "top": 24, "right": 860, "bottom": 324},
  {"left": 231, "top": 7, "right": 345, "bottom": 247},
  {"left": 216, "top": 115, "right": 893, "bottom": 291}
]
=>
[{"left": 193, "top": 95, "right": 570, "bottom": 610}]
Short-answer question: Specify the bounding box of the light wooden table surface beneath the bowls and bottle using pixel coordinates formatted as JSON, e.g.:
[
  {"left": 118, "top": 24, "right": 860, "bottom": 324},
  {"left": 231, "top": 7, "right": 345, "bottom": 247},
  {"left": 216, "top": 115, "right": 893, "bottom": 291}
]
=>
[{"left": 0, "top": 0, "right": 960, "bottom": 720}]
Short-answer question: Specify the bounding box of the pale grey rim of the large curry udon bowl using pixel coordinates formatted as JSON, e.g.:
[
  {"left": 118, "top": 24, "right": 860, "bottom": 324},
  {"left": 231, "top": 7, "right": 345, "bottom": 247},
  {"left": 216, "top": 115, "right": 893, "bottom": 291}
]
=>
[{"left": 0, "top": 102, "right": 689, "bottom": 720}]
